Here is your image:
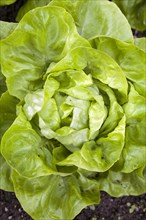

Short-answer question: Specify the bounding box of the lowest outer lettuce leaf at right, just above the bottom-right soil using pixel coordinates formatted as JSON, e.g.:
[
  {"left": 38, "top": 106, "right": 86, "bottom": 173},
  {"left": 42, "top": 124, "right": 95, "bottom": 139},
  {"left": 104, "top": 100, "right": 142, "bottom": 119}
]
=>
[{"left": 97, "top": 167, "right": 146, "bottom": 197}]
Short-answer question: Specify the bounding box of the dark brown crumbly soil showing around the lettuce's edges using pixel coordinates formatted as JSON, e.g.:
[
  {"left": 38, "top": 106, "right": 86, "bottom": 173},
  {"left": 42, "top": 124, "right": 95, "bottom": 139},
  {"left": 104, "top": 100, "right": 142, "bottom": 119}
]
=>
[{"left": 0, "top": 0, "right": 146, "bottom": 220}]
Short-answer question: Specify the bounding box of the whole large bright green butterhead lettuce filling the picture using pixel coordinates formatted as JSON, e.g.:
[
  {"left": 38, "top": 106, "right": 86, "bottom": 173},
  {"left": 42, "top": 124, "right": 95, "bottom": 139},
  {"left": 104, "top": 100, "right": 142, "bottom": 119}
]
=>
[{"left": 0, "top": 0, "right": 146, "bottom": 220}]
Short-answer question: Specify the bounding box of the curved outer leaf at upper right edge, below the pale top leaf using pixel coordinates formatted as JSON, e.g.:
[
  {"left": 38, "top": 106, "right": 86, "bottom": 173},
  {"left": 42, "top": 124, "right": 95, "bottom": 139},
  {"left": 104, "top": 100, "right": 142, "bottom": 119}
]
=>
[{"left": 92, "top": 37, "right": 146, "bottom": 96}]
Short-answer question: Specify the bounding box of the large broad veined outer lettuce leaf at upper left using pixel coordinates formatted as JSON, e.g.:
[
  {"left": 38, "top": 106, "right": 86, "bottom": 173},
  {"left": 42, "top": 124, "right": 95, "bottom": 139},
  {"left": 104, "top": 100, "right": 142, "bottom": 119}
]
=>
[{"left": 1, "top": 7, "right": 89, "bottom": 99}]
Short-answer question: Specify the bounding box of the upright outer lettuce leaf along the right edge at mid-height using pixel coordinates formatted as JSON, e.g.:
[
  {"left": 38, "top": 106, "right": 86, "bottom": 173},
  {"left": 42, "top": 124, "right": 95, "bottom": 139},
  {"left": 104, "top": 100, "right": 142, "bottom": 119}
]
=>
[{"left": 122, "top": 85, "right": 146, "bottom": 173}]
